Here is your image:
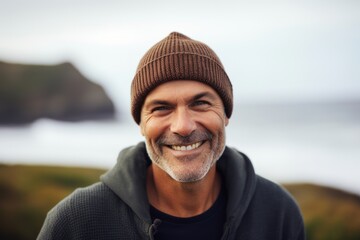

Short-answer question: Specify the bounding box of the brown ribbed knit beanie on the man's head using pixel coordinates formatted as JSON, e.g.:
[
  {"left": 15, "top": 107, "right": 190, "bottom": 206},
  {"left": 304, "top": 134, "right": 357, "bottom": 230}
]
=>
[{"left": 131, "top": 32, "right": 233, "bottom": 124}]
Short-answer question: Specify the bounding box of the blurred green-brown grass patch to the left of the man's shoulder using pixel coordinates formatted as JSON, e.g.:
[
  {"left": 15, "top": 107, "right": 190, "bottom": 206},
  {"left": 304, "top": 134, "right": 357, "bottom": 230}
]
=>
[{"left": 0, "top": 165, "right": 105, "bottom": 239}]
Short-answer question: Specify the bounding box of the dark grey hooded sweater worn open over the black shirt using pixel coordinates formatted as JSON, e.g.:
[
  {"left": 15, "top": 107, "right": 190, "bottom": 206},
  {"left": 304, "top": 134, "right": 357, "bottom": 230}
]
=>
[{"left": 38, "top": 143, "right": 305, "bottom": 240}]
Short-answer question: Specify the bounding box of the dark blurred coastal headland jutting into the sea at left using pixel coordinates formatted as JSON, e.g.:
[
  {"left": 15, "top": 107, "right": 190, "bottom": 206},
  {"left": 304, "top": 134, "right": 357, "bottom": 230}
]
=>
[{"left": 0, "top": 61, "right": 115, "bottom": 124}]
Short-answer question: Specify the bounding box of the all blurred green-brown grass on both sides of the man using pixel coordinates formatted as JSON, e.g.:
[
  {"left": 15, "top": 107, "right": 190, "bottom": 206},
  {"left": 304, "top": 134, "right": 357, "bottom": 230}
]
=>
[{"left": 0, "top": 164, "right": 360, "bottom": 240}]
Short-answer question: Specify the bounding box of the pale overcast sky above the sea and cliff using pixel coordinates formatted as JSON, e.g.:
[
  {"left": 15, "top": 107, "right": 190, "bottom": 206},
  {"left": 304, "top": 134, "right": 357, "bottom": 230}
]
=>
[{"left": 0, "top": 0, "right": 360, "bottom": 114}]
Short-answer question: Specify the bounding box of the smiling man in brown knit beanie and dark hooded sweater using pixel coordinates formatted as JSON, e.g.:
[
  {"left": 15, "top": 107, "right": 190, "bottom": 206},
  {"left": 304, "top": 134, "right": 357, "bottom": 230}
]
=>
[{"left": 38, "top": 32, "right": 304, "bottom": 240}]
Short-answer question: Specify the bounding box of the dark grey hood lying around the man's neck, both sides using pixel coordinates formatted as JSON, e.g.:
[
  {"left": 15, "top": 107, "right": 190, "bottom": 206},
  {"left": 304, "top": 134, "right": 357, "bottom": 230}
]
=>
[{"left": 101, "top": 142, "right": 256, "bottom": 228}]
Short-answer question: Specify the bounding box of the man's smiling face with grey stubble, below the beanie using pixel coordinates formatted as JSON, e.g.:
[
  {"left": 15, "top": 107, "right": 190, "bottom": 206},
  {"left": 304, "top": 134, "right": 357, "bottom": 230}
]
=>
[{"left": 140, "top": 80, "right": 228, "bottom": 182}]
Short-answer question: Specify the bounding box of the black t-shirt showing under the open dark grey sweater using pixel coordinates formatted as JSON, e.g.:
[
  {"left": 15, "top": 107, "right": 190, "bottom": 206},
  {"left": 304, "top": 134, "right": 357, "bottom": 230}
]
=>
[{"left": 150, "top": 188, "right": 226, "bottom": 240}]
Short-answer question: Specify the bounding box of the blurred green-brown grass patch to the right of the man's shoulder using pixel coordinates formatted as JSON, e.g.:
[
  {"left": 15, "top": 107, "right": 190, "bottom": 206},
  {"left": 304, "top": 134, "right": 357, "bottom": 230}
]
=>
[{"left": 284, "top": 184, "right": 360, "bottom": 240}]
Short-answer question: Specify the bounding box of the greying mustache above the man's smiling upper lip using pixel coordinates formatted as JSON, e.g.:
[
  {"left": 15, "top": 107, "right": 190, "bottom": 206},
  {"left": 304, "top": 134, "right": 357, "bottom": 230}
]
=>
[{"left": 156, "top": 130, "right": 213, "bottom": 145}]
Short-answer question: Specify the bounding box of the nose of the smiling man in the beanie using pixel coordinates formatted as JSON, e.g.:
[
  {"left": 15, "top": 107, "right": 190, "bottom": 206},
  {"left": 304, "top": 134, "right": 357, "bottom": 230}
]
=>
[{"left": 170, "top": 109, "right": 196, "bottom": 137}]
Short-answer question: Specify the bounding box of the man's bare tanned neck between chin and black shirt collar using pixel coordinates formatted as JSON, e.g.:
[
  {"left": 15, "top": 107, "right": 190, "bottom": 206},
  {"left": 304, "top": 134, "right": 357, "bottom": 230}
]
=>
[{"left": 146, "top": 164, "right": 221, "bottom": 217}]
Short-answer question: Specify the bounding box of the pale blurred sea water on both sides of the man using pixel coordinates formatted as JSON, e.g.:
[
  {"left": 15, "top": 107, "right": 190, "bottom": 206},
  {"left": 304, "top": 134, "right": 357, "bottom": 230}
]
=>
[{"left": 0, "top": 103, "right": 360, "bottom": 194}]
